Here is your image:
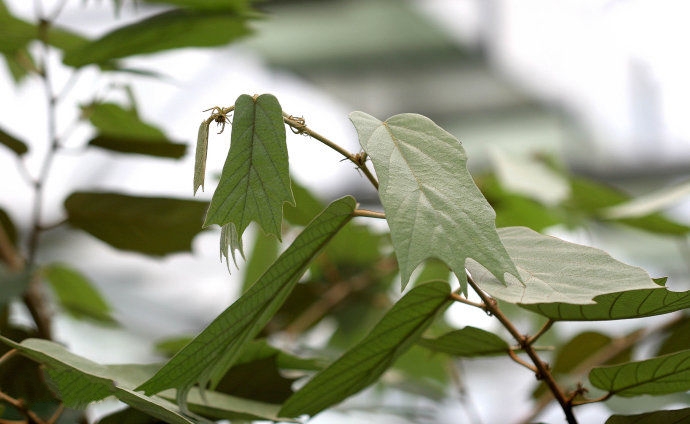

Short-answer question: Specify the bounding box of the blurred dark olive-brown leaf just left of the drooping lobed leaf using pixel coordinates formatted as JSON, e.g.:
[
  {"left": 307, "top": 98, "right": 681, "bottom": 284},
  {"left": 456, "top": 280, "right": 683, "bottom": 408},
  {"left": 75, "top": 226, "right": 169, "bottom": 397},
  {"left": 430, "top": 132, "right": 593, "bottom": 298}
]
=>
[{"left": 65, "top": 192, "right": 207, "bottom": 256}]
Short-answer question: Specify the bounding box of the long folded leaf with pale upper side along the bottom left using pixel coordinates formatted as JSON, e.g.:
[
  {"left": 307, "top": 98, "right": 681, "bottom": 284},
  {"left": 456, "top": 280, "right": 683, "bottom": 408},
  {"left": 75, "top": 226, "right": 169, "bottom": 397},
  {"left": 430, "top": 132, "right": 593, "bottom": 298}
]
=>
[{"left": 0, "top": 336, "right": 288, "bottom": 424}]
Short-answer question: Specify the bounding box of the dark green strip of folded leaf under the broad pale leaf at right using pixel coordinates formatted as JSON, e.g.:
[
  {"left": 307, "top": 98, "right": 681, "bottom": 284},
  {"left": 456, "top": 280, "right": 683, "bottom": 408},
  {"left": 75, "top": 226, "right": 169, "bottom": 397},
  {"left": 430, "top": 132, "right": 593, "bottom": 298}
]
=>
[{"left": 520, "top": 287, "right": 690, "bottom": 321}]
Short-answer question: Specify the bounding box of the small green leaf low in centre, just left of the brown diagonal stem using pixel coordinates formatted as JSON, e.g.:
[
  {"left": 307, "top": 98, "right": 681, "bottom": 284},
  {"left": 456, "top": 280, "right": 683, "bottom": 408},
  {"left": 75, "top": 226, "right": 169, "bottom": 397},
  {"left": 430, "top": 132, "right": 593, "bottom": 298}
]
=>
[{"left": 417, "top": 327, "right": 510, "bottom": 358}]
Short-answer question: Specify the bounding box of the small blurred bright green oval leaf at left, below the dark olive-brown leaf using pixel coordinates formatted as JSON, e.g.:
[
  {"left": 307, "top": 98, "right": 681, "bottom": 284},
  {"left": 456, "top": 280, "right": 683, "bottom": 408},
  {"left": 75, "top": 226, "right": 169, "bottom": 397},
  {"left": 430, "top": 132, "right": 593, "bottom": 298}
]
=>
[{"left": 43, "top": 264, "right": 115, "bottom": 323}]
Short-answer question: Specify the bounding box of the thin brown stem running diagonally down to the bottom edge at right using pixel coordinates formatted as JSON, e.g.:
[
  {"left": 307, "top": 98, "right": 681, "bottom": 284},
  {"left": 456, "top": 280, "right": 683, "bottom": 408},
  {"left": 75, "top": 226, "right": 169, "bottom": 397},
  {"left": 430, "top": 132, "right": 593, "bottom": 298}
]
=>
[{"left": 467, "top": 273, "right": 577, "bottom": 424}]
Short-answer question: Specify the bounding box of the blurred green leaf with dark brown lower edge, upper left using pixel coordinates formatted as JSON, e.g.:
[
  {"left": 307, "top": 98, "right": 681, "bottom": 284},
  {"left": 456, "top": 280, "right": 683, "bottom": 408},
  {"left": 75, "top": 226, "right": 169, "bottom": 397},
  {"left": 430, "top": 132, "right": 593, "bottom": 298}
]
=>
[{"left": 82, "top": 103, "right": 187, "bottom": 159}]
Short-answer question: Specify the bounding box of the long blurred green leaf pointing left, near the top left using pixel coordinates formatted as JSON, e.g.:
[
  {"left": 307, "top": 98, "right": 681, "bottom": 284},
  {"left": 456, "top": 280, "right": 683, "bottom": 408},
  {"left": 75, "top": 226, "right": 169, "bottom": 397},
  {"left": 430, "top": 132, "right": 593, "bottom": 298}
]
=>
[{"left": 63, "top": 9, "right": 249, "bottom": 67}]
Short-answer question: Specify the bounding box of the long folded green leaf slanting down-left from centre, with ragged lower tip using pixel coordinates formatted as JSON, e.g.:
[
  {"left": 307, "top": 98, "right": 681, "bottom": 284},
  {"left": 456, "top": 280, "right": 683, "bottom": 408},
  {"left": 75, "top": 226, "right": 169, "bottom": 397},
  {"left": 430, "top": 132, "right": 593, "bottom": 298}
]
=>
[{"left": 138, "top": 197, "right": 355, "bottom": 405}]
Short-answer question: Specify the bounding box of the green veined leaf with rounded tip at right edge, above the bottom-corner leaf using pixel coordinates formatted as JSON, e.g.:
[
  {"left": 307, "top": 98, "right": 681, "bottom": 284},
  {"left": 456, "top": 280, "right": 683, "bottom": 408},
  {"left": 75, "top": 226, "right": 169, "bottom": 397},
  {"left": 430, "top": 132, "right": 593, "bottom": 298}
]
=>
[{"left": 589, "top": 350, "right": 690, "bottom": 397}]
